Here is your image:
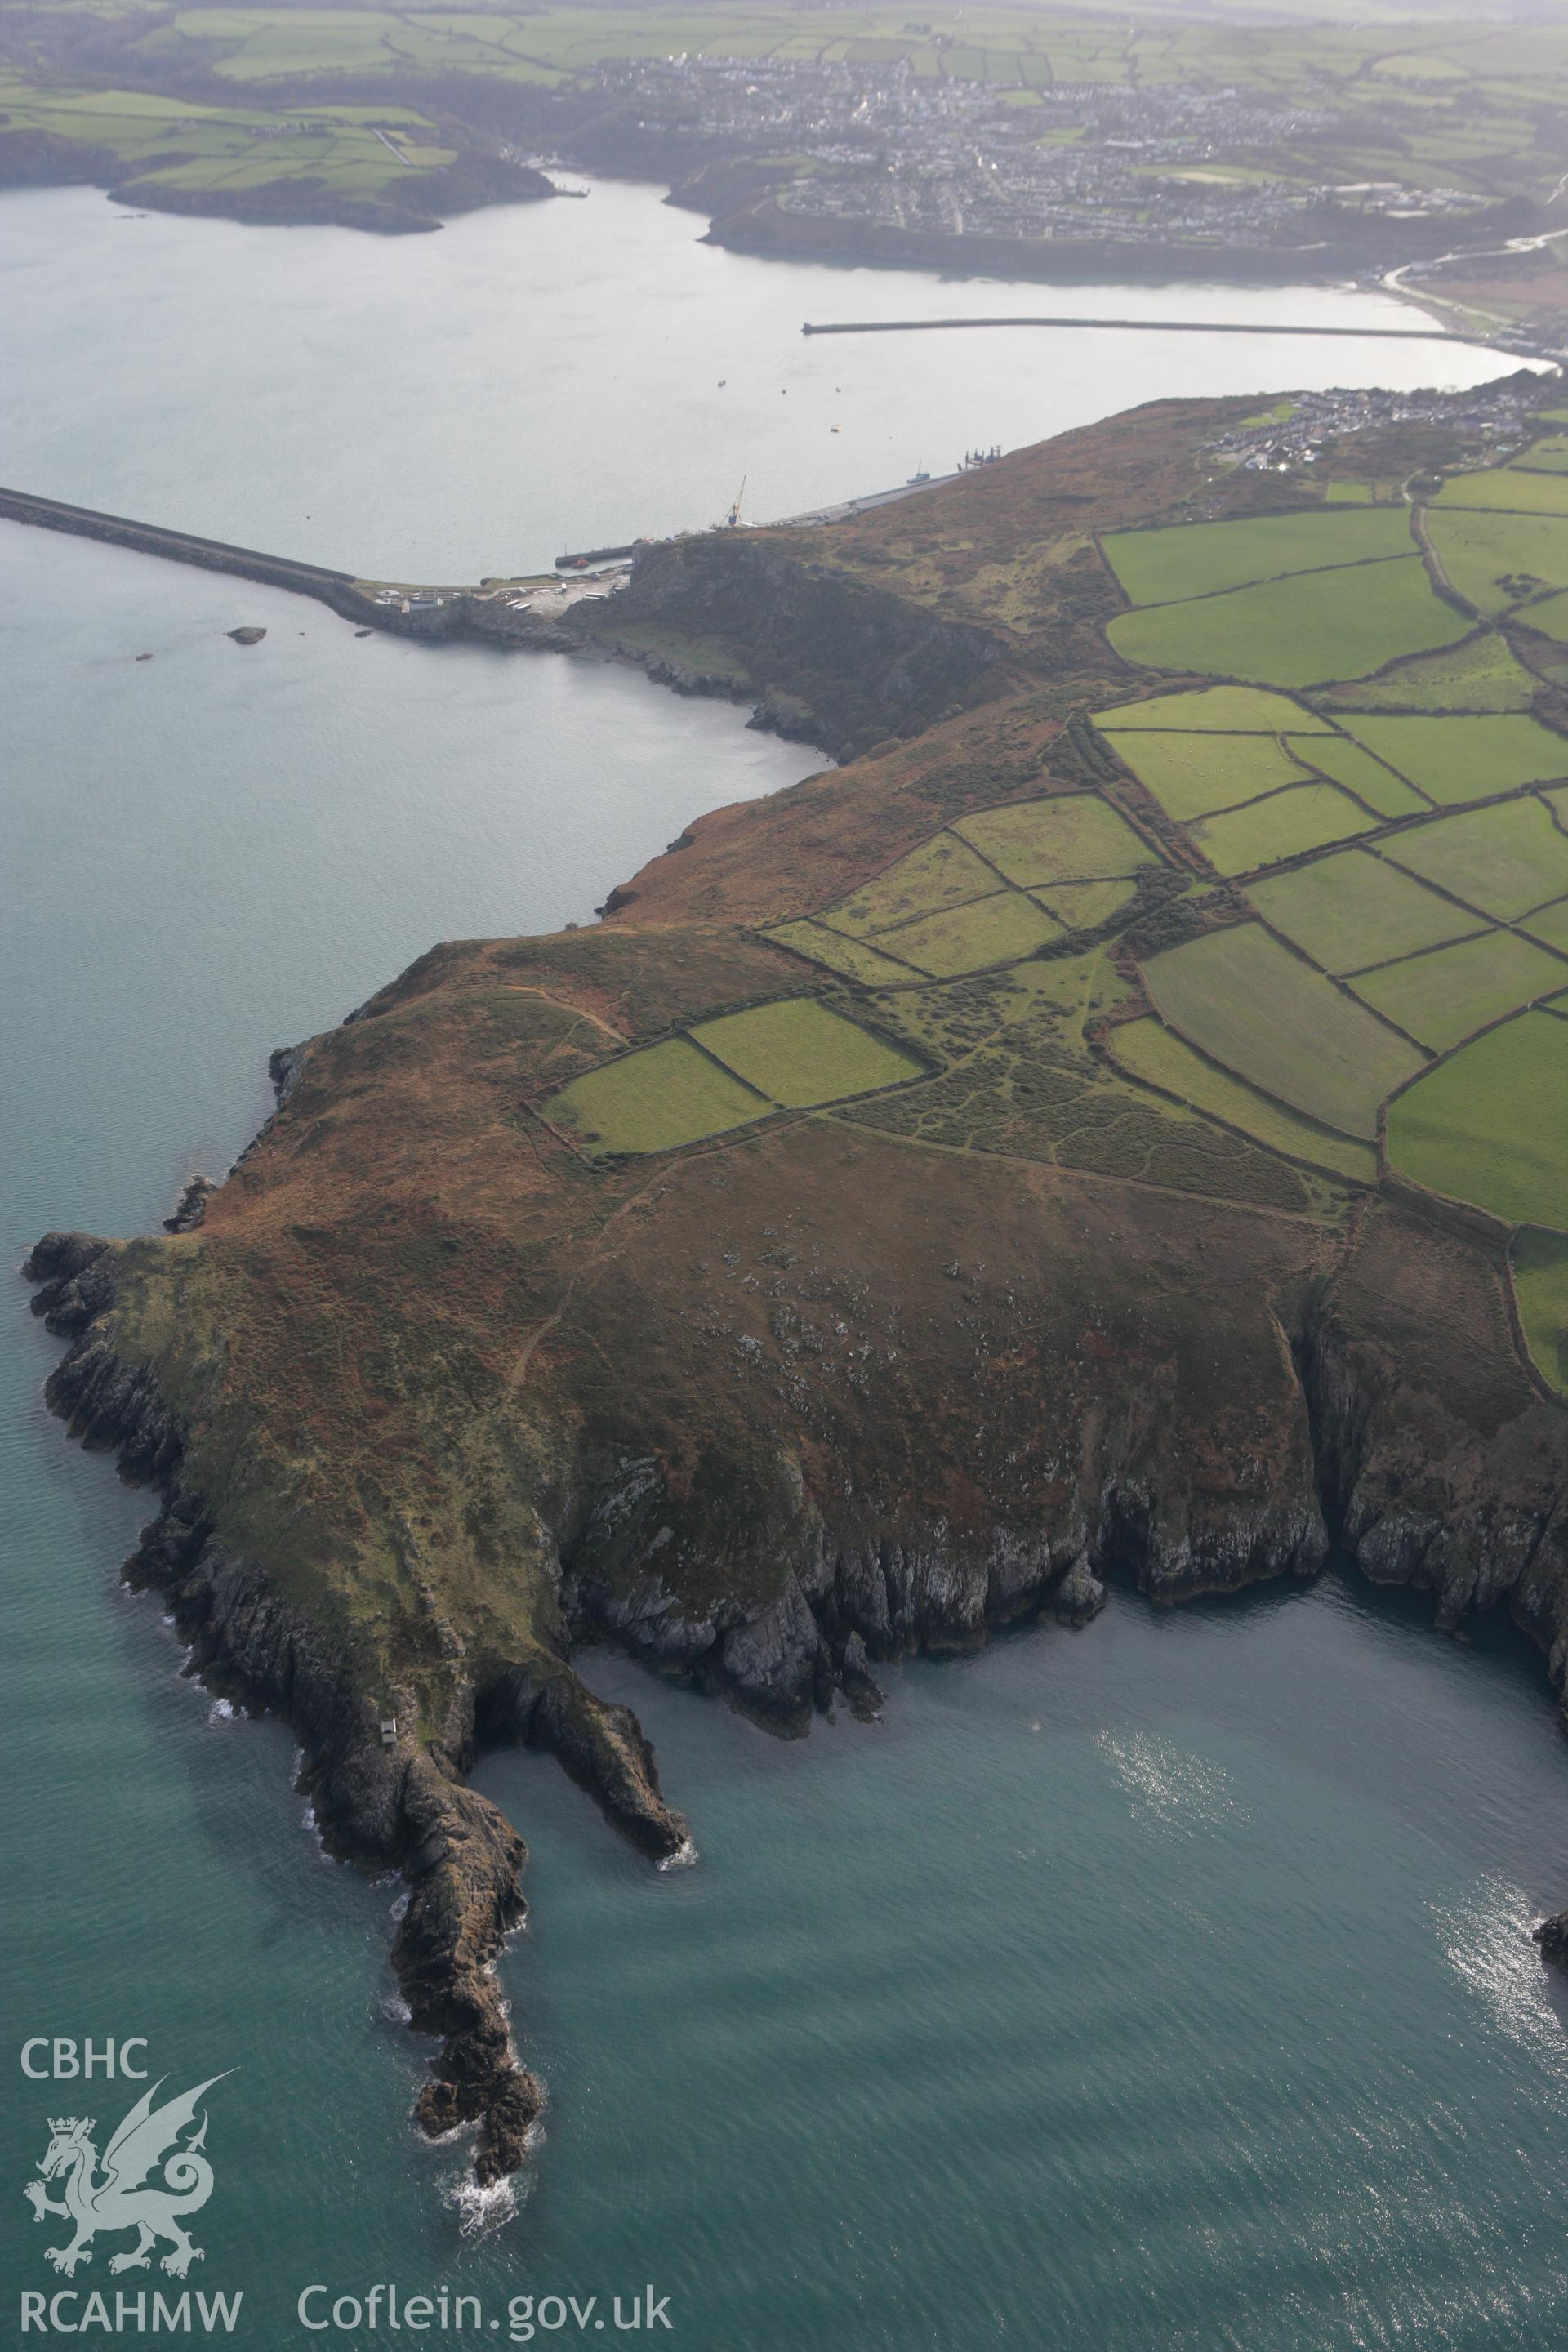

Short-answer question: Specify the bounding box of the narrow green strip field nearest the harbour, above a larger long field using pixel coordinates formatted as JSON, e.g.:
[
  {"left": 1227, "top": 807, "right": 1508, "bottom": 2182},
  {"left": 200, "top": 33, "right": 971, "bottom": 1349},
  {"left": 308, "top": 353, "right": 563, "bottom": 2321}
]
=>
[{"left": 1100, "top": 506, "right": 1410, "bottom": 604}]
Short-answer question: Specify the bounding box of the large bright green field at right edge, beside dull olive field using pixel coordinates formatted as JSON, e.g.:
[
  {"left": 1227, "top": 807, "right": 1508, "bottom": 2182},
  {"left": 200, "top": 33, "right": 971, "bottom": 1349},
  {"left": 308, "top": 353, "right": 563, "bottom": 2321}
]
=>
[{"left": 1387, "top": 1011, "right": 1568, "bottom": 1230}]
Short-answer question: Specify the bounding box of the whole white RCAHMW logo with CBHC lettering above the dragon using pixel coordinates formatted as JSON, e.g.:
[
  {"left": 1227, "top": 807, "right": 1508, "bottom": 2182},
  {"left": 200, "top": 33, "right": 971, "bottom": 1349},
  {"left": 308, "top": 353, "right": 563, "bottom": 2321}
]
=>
[{"left": 21, "top": 2034, "right": 244, "bottom": 2336}]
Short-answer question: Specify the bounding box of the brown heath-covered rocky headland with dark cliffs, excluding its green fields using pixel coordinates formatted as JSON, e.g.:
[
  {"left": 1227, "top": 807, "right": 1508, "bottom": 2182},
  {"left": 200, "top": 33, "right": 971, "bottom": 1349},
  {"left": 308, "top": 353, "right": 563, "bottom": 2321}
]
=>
[{"left": 29, "top": 402, "right": 1568, "bottom": 2180}]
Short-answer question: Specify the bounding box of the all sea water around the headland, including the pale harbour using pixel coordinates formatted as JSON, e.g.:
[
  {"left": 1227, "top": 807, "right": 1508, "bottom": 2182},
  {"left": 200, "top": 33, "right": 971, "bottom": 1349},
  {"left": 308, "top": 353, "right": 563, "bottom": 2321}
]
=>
[{"left": 0, "top": 174, "right": 1568, "bottom": 2352}]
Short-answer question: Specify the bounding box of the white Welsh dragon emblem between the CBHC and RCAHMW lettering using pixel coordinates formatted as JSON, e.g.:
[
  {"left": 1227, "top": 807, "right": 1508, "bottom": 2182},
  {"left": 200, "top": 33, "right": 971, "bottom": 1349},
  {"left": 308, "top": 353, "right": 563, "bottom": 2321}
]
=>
[{"left": 21, "top": 2069, "right": 233, "bottom": 2279}]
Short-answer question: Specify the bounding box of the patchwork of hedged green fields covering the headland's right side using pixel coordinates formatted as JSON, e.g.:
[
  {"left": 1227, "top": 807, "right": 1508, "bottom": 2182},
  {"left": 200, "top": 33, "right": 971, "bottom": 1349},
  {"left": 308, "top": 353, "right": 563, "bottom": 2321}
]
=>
[{"left": 546, "top": 430, "right": 1568, "bottom": 1385}]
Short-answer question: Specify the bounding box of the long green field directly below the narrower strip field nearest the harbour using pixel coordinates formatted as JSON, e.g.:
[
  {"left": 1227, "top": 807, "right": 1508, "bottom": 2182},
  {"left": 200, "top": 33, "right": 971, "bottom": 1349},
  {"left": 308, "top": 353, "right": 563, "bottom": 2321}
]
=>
[{"left": 1105, "top": 559, "right": 1476, "bottom": 687}]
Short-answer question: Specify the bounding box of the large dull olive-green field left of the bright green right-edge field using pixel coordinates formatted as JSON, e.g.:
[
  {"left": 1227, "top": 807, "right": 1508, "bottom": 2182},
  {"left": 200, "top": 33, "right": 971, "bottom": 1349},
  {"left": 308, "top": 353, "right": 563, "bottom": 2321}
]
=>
[{"left": 1143, "top": 922, "right": 1429, "bottom": 1138}]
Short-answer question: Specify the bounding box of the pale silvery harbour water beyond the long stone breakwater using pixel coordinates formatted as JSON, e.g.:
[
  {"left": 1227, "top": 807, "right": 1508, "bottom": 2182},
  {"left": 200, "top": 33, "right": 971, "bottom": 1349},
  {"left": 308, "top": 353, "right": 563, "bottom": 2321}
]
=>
[{"left": 0, "top": 181, "right": 1500, "bottom": 581}]
